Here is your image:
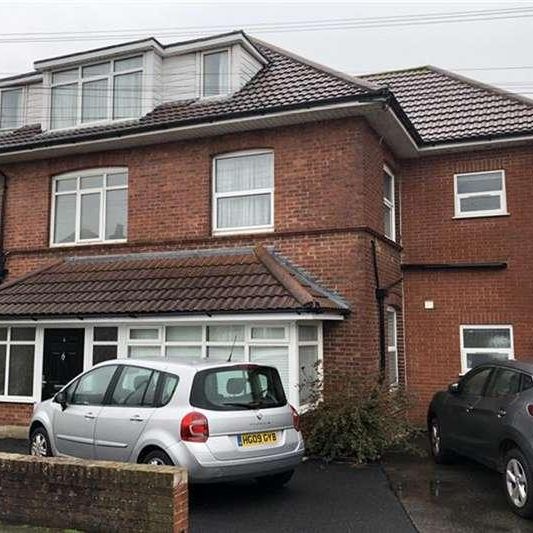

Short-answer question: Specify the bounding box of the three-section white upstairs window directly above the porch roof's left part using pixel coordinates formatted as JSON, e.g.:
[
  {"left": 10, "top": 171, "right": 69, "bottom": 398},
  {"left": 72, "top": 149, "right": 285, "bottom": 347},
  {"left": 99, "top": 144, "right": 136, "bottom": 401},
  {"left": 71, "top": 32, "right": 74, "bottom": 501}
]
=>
[{"left": 51, "top": 168, "right": 128, "bottom": 246}]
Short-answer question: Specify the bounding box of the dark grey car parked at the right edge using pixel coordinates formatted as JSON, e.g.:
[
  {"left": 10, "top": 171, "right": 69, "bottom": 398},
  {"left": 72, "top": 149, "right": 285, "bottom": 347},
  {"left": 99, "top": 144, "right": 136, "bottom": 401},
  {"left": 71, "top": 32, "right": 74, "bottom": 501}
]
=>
[{"left": 427, "top": 361, "right": 533, "bottom": 517}]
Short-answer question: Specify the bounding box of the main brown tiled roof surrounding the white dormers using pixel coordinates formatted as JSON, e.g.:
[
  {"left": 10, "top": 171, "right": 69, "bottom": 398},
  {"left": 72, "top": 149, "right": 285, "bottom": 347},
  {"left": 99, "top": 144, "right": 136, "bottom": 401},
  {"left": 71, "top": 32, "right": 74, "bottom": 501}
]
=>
[{"left": 0, "top": 41, "right": 376, "bottom": 152}]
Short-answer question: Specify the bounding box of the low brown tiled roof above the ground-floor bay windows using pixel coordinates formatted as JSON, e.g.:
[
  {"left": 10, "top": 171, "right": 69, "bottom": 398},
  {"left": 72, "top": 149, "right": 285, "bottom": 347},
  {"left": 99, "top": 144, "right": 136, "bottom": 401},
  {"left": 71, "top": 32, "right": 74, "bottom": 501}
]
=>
[{"left": 0, "top": 246, "right": 349, "bottom": 318}]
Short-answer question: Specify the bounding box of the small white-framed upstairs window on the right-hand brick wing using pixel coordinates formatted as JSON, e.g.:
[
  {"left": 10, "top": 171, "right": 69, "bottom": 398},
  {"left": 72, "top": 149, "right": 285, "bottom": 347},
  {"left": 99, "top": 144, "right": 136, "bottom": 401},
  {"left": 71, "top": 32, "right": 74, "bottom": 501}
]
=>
[{"left": 455, "top": 170, "right": 507, "bottom": 218}]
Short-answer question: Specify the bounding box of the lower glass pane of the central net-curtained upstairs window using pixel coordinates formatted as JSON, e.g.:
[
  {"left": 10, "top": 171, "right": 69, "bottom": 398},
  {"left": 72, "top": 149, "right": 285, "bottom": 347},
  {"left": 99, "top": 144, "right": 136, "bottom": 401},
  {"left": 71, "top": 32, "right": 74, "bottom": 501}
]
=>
[{"left": 217, "top": 194, "right": 272, "bottom": 228}]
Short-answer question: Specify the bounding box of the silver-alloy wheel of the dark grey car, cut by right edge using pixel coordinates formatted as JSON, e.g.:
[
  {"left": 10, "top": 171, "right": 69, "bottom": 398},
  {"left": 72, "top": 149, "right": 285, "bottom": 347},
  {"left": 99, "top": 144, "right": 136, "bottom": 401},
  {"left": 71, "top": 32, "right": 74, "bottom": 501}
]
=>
[{"left": 503, "top": 448, "right": 533, "bottom": 518}]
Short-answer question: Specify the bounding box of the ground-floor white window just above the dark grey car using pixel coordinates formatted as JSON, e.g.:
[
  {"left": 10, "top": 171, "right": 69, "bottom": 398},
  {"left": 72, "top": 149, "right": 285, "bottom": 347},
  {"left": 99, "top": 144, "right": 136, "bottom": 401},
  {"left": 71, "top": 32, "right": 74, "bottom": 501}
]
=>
[{"left": 461, "top": 326, "right": 514, "bottom": 372}]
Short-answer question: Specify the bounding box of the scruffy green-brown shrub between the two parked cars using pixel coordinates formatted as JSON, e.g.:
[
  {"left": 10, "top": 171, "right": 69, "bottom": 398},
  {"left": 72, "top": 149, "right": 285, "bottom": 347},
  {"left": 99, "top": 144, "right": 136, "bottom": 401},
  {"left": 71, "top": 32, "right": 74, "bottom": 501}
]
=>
[{"left": 302, "top": 378, "right": 413, "bottom": 463}]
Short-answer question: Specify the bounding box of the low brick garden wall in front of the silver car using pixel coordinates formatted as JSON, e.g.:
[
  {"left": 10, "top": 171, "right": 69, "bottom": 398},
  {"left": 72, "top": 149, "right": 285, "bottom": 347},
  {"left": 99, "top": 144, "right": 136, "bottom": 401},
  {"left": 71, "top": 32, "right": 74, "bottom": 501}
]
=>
[{"left": 0, "top": 453, "right": 188, "bottom": 533}]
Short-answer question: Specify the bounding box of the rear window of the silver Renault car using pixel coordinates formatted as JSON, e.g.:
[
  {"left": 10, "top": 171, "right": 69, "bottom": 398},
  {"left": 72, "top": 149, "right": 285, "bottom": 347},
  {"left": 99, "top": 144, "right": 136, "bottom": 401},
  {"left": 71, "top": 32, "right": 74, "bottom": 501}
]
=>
[{"left": 190, "top": 365, "right": 287, "bottom": 411}]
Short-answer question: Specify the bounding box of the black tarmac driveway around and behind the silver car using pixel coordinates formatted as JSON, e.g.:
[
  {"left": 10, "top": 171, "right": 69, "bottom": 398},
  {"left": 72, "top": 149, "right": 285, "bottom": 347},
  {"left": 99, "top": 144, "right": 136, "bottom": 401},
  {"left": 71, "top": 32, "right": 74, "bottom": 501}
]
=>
[{"left": 0, "top": 439, "right": 416, "bottom": 533}]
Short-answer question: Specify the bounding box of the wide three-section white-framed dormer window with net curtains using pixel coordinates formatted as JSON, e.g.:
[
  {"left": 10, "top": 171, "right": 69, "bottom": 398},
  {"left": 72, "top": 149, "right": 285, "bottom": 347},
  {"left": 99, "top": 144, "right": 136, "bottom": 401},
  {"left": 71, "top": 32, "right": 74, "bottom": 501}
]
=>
[{"left": 50, "top": 56, "right": 143, "bottom": 129}]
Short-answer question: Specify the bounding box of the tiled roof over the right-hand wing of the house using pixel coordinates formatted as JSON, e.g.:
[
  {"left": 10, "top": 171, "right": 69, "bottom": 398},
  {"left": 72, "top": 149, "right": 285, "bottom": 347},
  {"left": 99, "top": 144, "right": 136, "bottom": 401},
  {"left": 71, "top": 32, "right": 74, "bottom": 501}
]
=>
[{"left": 362, "top": 66, "right": 533, "bottom": 143}]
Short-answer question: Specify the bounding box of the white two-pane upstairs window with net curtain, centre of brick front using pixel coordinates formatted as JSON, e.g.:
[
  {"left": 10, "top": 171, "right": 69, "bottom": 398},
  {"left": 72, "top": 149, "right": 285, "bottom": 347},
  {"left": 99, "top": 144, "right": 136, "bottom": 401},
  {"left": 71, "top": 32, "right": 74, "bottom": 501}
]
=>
[{"left": 213, "top": 151, "right": 274, "bottom": 233}]
